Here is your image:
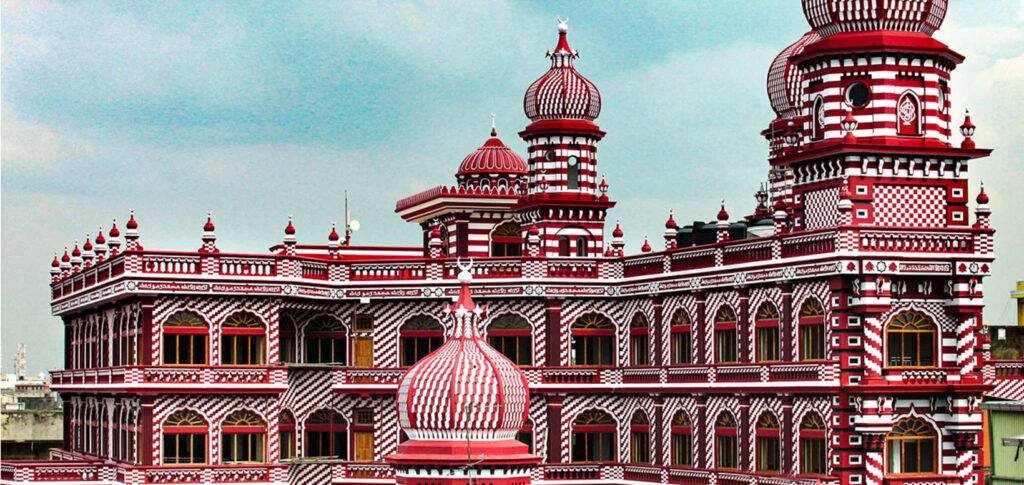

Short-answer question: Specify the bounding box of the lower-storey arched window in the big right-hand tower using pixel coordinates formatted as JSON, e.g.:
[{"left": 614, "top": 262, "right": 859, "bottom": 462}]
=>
[{"left": 886, "top": 417, "right": 939, "bottom": 475}]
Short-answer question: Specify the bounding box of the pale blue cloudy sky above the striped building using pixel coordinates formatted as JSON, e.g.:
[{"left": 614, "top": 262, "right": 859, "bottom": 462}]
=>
[{"left": 6, "top": 0, "right": 1024, "bottom": 372}]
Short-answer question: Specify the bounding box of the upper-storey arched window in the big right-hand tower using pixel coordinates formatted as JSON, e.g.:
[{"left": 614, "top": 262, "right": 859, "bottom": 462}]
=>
[{"left": 886, "top": 311, "right": 937, "bottom": 367}]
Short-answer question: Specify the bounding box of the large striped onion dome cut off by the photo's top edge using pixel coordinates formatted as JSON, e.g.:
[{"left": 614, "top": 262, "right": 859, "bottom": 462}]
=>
[{"left": 801, "top": 0, "right": 948, "bottom": 37}]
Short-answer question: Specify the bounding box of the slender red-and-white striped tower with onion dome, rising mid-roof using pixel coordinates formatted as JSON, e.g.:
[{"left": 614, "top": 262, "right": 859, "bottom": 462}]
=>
[{"left": 517, "top": 19, "right": 614, "bottom": 257}]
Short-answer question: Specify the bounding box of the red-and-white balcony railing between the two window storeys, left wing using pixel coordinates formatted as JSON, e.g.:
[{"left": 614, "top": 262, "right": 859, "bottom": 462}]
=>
[{"left": 50, "top": 365, "right": 288, "bottom": 393}]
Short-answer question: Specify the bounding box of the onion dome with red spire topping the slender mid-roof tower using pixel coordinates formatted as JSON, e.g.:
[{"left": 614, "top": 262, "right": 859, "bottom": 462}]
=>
[{"left": 522, "top": 19, "right": 601, "bottom": 122}]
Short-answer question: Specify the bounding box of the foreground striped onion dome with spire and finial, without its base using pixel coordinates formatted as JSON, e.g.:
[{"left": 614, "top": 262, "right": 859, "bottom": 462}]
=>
[{"left": 389, "top": 263, "right": 534, "bottom": 446}]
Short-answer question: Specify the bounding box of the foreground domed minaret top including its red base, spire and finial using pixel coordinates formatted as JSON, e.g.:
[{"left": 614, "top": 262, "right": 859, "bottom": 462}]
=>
[{"left": 386, "top": 262, "right": 540, "bottom": 485}]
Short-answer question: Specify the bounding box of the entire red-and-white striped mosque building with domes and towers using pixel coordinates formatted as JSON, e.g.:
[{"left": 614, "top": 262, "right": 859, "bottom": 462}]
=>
[{"left": 0, "top": 0, "right": 1024, "bottom": 485}]
